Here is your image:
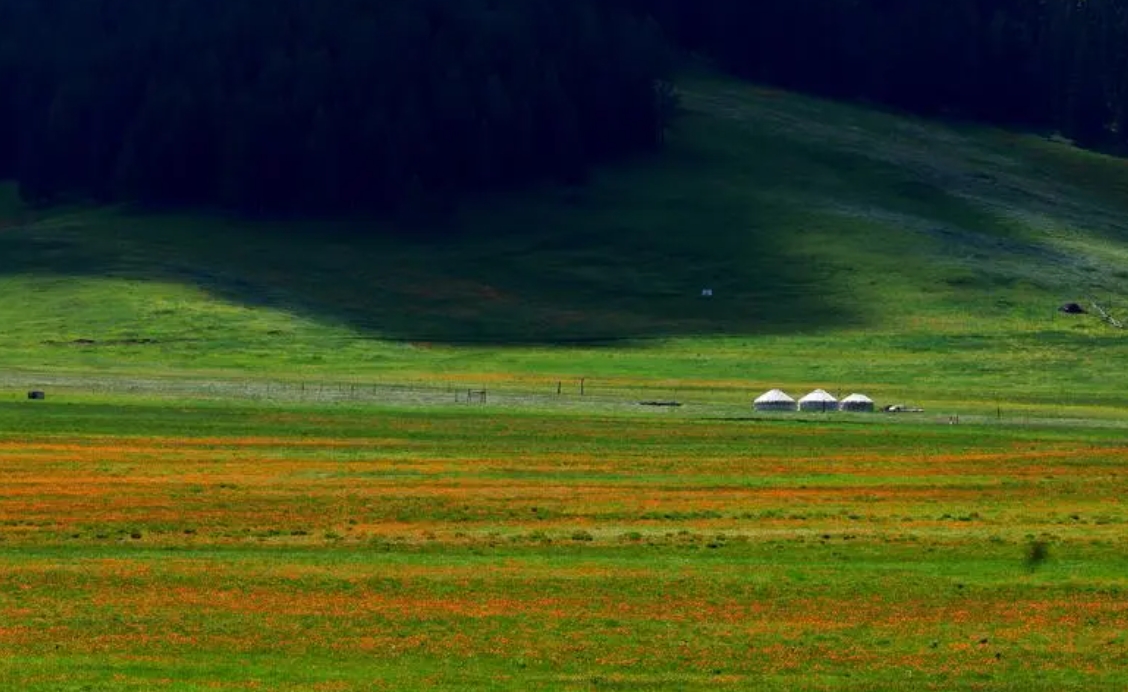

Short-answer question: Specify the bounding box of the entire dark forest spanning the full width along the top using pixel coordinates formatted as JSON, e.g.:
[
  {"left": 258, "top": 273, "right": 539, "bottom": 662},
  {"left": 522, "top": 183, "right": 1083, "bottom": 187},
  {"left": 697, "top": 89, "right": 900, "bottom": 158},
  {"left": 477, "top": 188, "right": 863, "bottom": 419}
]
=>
[{"left": 0, "top": 0, "right": 1128, "bottom": 212}]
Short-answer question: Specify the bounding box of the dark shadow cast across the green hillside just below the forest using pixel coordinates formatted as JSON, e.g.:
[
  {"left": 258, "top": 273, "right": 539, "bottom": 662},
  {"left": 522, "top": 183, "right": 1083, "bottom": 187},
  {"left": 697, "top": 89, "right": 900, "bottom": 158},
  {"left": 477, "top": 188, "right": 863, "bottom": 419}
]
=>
[{"left": 0, "top": 130, "right": 1105, "bottom": 345}]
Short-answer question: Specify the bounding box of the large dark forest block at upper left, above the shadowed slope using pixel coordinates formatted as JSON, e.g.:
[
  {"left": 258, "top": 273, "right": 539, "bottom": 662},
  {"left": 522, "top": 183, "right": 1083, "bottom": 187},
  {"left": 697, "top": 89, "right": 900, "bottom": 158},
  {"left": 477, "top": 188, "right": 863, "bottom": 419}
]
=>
[{"left": 0, "top": 0, "right": 670, "bottom": 212}]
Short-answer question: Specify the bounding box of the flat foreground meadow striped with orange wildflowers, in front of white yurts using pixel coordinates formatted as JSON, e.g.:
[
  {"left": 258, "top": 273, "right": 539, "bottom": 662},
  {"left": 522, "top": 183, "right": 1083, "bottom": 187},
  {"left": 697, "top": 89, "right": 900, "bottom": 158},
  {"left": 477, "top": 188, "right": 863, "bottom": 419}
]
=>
[{"left": 0, "top": 403, "right": 1128, "bottom": 690}]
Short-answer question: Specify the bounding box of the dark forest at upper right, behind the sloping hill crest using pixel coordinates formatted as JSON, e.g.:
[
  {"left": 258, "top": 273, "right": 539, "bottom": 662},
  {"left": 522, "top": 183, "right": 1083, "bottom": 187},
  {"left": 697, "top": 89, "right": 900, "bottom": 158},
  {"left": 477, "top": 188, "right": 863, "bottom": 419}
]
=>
[{"left": 640, "top": 0, "right": 1128, "bottom": 151}]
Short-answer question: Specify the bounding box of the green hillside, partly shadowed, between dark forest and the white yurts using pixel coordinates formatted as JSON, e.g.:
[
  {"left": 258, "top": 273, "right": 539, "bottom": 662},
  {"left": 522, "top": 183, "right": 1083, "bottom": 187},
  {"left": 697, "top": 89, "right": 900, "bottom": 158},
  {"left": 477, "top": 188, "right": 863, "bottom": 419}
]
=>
[{"left": 0, "top": 76, "right": 1128, "bottom": 413}]
